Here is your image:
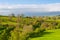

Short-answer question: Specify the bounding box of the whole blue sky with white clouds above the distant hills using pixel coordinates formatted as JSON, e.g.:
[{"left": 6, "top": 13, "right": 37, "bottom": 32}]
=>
[{"left": 0, "top": 0, "right": 60, "bottom": 14}]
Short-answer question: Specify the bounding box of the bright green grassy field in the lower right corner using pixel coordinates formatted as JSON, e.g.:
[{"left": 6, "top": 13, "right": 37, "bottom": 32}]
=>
[{"left": 31, "top": 29, "right": 60, "bottom": 40}]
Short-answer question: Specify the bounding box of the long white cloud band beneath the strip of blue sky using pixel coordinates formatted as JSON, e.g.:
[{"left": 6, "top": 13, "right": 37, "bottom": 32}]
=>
[{"left": 0, "top": 3, "right": 60, "bottom": 12}]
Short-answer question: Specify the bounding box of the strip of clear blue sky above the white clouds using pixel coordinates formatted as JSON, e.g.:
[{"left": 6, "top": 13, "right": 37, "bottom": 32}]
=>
[{"left": 0, "top": 0, "right": 60, "bottom": 4}]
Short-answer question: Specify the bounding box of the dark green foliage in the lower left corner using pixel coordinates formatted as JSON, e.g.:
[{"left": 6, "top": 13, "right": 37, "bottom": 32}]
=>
[{"left": 0, "top": 25, "right": 14, "bottom": 40}]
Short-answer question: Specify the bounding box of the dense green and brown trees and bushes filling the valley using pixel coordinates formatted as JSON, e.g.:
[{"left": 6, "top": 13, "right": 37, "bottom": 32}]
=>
[{"left": 0, "top": 14, "right": 60, "bottom": 40}]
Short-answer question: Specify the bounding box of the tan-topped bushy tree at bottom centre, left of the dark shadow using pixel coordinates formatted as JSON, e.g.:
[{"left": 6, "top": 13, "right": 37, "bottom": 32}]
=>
[{"left": 21, "top": 25, "right": 33, "bottom": 40}]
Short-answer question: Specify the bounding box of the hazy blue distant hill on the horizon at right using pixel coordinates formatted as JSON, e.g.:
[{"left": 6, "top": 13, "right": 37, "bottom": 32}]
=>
[{"left": 25, "top": 12, "right": 60, "bottom": 16}]
